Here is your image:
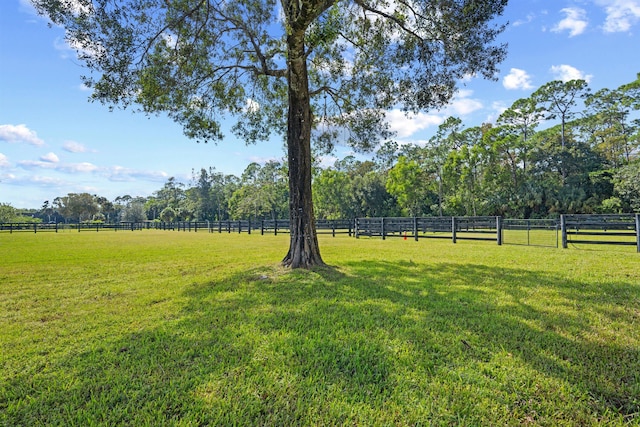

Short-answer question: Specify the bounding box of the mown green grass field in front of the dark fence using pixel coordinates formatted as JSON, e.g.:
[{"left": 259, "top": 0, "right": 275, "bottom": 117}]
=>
[{"left": 0, "top": 231, "right": 640, "bottom": 426}]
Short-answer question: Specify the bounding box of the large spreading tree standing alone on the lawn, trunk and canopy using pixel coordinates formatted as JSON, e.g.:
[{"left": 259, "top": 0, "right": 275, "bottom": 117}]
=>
[{"left": 32, "top": 0, "right": 507, "bottom": 268}]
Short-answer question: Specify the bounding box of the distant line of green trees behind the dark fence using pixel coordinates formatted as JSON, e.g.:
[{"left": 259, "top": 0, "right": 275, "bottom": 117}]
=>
[{"left": 0, "top": 74, "right": 640, "bottom": 223}]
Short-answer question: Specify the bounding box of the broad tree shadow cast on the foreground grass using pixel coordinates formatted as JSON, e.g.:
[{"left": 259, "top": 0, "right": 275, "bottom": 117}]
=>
[{"left": 0, "top": 261, "right": 640, "bottom": 425}]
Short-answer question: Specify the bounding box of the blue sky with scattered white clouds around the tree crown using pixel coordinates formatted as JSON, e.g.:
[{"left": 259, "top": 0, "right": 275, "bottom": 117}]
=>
[{"left": 0, "top": 0, "right": 640, "bottom": 208}]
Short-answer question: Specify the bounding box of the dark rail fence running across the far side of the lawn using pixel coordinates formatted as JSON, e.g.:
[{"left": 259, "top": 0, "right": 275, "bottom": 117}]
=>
[{"left": 0, "top": 213, "right": 640, "bottom": 253}]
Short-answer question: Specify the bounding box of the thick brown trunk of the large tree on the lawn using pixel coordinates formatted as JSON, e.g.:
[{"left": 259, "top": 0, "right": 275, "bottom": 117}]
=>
[{"left": 282, "top": 35, "right": 324, "bottom": 268}]
